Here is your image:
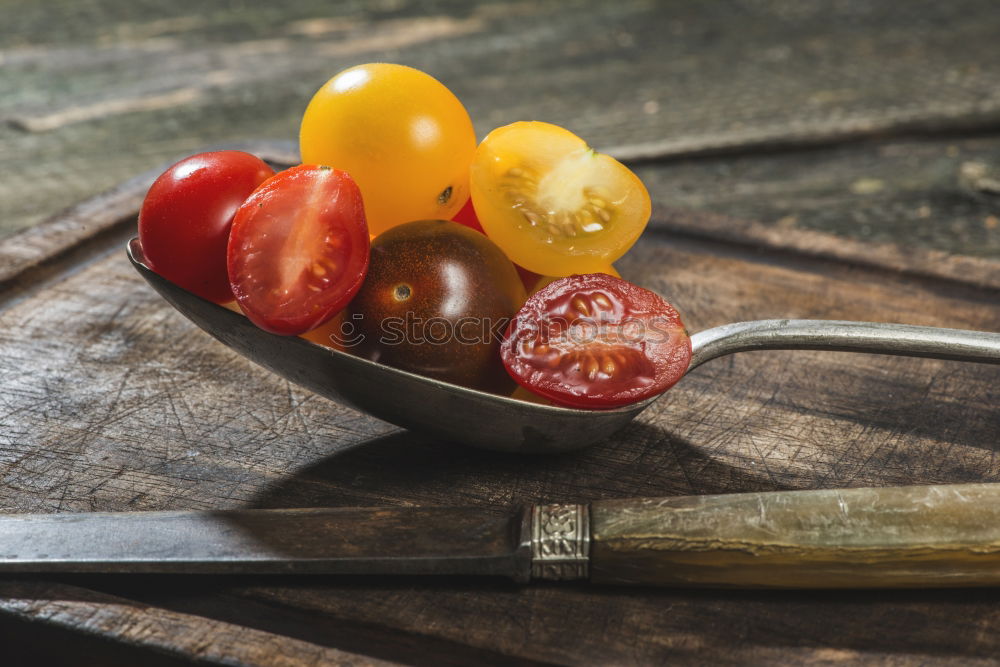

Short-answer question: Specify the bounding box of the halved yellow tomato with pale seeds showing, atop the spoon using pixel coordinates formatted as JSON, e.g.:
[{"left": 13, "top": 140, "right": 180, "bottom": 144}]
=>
[{"left": 470, "top": 121, "right": 651, "bottom": 277}]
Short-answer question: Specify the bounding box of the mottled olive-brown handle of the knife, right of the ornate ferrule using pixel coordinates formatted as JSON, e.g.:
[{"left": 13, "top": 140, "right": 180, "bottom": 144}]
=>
[{"left": 587, "top": 484, "right": 1000, "bottom": 588}]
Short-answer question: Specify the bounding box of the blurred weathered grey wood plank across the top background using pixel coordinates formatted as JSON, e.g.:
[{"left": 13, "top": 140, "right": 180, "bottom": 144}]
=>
[{"left": 0, "top": 0, "right": 1000, "bottom": 250}]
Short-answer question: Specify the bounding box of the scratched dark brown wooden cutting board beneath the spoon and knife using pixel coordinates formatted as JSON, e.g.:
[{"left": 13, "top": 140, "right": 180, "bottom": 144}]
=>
[{"left": 0, "top": 144, "right": 1000, "bottom": 664}]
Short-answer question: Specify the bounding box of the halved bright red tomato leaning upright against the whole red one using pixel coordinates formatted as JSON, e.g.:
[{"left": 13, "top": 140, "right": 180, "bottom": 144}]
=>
[{"left": 228, "top": 165, "right": 369, "bottom": 335}]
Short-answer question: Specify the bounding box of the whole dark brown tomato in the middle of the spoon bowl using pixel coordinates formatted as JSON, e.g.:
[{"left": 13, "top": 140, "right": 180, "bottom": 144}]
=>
[{"left": 347, "top": 220, "right": 526, "bottom": 394}]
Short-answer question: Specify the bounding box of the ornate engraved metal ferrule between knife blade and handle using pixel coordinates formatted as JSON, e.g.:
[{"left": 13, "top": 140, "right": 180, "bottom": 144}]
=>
[{"left": 531, "top": 505, "right": 590, "bottom": 579}]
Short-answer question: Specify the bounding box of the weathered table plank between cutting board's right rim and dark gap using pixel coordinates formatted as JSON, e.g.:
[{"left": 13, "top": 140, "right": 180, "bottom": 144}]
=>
[{"left": 637, "top": 135, "right": 1000, "bottom": 276}]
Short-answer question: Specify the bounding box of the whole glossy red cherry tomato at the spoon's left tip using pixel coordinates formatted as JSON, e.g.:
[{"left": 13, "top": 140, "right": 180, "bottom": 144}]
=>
[{"left": 139, "top": 151, "right": 274, "bottom": 303}]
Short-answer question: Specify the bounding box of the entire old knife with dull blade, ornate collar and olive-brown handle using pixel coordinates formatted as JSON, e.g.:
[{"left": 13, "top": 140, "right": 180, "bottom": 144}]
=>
[{"left": 0, "top": 484, "right": 1000, "bottom": 588}]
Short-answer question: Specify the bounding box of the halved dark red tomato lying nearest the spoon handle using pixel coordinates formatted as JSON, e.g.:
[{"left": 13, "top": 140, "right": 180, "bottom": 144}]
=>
[{"left": 500, "top": 273, "right": 691, "bottom": 408}]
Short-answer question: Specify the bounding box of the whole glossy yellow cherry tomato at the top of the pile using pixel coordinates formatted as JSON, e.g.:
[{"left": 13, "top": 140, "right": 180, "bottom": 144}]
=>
[{"left": 299, "top": 63, "right": 476, "bottom": 235}]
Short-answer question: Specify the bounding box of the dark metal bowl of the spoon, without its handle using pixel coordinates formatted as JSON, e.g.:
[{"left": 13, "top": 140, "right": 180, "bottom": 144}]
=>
[{"left": 128, "top": 238, "right": 655, "bottom": 452}]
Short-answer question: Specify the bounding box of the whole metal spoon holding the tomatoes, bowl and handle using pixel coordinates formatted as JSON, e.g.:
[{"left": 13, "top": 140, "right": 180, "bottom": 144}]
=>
[{"left": 128, "top": 239, "right": 1000, "bottom": 452}]
